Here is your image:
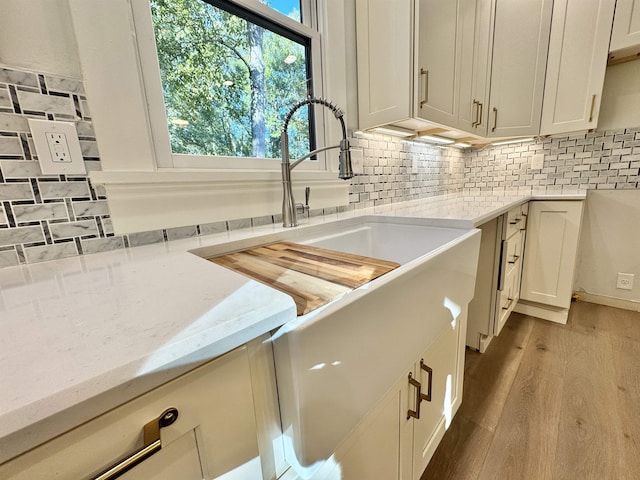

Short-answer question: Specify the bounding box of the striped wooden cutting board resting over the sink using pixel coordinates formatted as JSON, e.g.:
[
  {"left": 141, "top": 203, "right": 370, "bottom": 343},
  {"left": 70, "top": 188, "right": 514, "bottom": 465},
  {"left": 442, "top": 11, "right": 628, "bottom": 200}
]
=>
[{"left": 208, "top": 242, "right": 400, "bottom": 315}]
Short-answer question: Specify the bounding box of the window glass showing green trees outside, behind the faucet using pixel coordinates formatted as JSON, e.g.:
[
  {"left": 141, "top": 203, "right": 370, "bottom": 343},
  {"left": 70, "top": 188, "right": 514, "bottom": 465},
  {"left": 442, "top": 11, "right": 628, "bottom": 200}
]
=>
[{"left": 150, "top": 0, "right": 315, "bottom": 158}]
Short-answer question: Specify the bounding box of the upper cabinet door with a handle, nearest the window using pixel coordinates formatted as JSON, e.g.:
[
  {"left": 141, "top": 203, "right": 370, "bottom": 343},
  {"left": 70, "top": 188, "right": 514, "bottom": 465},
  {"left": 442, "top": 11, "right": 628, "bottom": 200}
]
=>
[{"left": 414, "top": 0, "right": 460, "bottom": 127}]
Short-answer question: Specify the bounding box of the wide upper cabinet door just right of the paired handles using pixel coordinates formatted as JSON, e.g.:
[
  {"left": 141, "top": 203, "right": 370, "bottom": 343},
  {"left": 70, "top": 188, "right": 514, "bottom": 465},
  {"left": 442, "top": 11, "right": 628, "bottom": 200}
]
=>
[{"left": 486, "top": 0, "right": 553, "bottom": 137}]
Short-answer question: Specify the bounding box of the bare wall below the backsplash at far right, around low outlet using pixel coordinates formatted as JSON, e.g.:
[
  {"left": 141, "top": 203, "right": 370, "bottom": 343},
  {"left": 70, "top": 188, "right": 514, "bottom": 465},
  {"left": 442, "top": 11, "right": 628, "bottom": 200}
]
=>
[{"left": 574, "top": 190, "right": 640, "bottom": 307}]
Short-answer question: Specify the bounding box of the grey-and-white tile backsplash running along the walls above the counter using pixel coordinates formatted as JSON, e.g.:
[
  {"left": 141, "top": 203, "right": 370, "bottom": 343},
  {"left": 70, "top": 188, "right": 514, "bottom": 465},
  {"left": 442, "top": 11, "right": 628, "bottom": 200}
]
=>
[{"left": 0, "top": 62, "right": 640, "bottom": 268}]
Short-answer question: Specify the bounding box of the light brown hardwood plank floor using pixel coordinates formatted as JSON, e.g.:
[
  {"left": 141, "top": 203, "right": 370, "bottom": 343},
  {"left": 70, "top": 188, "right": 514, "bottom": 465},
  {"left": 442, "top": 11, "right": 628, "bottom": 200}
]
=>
[{"left": 421, "top": 302, "right": 640, "bottom": 480}]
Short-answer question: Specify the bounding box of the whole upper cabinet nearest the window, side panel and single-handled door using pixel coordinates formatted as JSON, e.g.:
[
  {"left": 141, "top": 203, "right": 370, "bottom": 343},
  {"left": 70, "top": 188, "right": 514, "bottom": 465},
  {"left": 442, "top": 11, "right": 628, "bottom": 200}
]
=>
[{"left": 356, "top": 0, "right": 461, "bottom": 131}]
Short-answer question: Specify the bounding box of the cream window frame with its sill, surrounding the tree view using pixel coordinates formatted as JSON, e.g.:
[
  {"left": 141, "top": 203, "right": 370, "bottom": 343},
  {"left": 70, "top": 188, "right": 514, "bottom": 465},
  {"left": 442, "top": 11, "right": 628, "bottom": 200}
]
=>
[{"left": 69, "top": 0, "right": 349, "bottom": 234}]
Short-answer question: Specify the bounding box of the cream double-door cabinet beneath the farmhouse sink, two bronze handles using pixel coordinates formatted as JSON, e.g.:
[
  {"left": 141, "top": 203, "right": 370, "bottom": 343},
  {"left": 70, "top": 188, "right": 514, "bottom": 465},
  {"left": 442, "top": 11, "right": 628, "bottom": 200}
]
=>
[{"left": 313, "top": 311, "right": 466, "bottom": 480}]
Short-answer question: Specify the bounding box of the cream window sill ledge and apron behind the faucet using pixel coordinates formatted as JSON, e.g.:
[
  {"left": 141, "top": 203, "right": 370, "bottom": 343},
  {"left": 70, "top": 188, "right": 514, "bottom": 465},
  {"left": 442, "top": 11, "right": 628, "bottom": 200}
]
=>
[{"left": 89, "top": 169, "right": 349, "bottom": 235}]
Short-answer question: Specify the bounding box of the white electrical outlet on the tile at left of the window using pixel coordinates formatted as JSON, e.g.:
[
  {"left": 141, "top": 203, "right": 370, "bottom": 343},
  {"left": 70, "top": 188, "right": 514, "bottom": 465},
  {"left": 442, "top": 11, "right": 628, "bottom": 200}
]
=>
[{"left": 29, "top": 118, "right": 87, "bottom": 175}]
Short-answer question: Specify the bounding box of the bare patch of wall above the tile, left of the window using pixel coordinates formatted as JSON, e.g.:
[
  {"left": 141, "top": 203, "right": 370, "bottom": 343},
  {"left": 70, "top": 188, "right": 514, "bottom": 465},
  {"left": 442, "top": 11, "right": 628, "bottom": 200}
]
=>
[{"left": 0, "top": 0, "right": 82, "bottom": 79}]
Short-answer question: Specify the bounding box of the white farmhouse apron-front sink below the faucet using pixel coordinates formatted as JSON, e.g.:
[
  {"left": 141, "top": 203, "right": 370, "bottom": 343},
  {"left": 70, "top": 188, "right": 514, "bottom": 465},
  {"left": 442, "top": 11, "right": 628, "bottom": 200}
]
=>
[{"left": 264, "top": 217, "right": 480, "bottom": 478}]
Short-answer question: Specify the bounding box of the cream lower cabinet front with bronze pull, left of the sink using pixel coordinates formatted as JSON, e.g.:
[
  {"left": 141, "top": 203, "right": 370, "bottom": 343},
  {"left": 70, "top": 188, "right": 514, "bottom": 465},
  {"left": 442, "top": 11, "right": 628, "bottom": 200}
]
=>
[{"left": 0, "top": 343, "right": 281, "bottom": 480}]
